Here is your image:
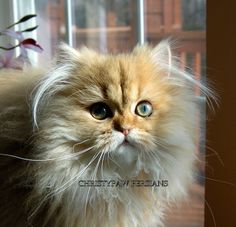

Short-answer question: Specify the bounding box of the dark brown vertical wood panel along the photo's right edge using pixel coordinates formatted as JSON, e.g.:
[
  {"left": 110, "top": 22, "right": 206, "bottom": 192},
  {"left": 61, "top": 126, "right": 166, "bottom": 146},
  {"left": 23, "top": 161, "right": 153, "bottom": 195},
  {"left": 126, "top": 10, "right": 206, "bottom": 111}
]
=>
[{"left": 205, "top": 0, "right": 236, "bottom": 227}]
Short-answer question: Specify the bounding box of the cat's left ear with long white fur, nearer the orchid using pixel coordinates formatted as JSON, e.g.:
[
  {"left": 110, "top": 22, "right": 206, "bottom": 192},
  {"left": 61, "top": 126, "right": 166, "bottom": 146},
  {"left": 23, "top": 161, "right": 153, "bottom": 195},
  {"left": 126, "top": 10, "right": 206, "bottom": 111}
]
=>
[{"left": 56, "top": 43, "right": 81, "bottom": 64}]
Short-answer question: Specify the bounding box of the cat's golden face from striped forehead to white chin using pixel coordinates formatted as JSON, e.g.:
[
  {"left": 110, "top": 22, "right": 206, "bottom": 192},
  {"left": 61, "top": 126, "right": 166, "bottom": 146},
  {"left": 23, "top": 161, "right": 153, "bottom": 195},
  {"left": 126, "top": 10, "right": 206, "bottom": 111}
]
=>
[{"left": 68, "top": 56, "right": 171, "bottom": 168}]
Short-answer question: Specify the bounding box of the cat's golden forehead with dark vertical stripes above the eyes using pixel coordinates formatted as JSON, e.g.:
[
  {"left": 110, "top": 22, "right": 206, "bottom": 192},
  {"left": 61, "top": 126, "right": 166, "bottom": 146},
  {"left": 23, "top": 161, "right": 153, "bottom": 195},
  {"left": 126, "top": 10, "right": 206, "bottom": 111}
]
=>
[{"left": 72, "top": 55, "right": 160, "bottom": 108}]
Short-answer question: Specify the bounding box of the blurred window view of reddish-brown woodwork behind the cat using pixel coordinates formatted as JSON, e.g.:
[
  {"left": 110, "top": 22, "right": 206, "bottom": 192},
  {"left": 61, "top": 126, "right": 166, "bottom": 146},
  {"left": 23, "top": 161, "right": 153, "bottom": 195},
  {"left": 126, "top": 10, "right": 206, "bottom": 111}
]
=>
[{"left": 0, "top": 0, "right": 206, "bottom": 227}]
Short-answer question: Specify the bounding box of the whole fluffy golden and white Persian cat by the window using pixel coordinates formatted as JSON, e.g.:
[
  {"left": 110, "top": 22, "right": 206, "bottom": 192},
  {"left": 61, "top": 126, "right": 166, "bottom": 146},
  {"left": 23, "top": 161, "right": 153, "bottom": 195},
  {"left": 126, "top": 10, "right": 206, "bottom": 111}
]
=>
[{"left": 0, "top": 41, "right": 211, "bottom": 227}]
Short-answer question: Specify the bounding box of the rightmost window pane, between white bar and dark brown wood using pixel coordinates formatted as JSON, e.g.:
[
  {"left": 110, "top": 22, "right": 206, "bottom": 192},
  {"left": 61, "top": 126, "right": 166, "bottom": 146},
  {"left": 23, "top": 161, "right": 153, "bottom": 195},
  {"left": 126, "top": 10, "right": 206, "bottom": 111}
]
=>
[{"left": 145, "top": 0, "right": 206, "bottom": 227}]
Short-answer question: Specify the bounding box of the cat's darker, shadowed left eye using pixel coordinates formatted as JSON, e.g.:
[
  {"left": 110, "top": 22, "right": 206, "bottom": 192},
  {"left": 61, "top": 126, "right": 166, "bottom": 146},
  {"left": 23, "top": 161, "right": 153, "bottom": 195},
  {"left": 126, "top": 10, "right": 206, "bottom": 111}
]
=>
[{"left": 90, "top": 102, "right": 112, "bottom": 120}]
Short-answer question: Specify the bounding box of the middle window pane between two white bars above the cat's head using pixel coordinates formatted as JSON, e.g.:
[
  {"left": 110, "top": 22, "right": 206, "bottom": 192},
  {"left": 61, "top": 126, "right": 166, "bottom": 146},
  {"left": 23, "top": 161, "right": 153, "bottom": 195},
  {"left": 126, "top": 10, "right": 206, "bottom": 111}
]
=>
[{"left": 74, "top": 0, "right": 135, "bottom": 52}]
